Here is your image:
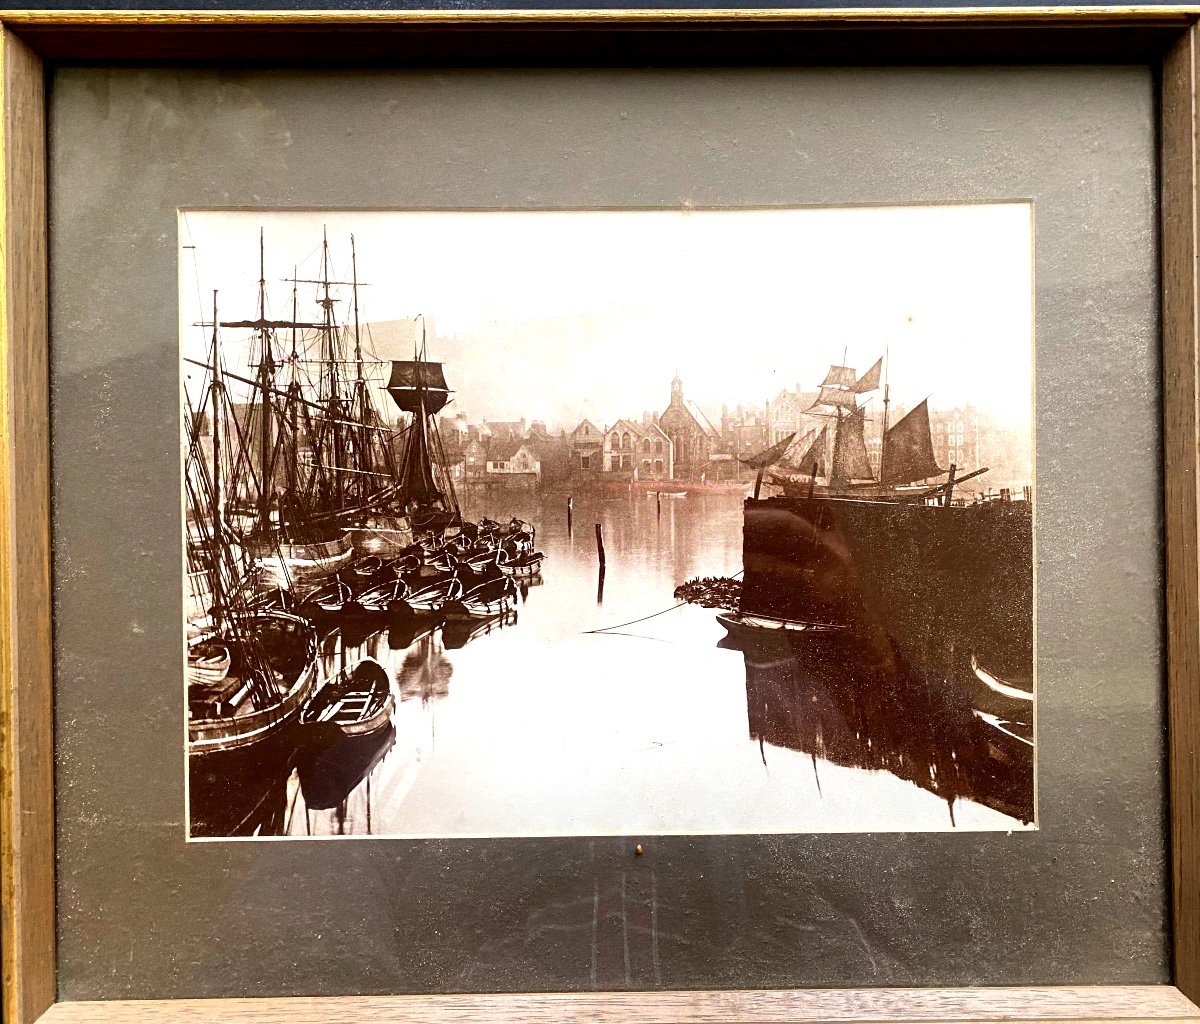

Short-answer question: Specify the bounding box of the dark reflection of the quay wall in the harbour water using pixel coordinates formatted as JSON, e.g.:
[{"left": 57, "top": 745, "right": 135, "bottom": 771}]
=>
[{"left": 719, "top": 631, "right": 1033, "bottom": 824}]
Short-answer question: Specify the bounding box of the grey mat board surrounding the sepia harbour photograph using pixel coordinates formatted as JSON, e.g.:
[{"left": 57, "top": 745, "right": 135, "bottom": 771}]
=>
[{"left": 50, "top": 68, "right": 1168, "bottom": 999}]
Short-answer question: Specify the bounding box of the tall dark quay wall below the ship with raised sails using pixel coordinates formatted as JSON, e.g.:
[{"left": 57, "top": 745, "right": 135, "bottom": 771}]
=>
[{"left": 740, "top": 497, "right": 1033, "bottom": 685}]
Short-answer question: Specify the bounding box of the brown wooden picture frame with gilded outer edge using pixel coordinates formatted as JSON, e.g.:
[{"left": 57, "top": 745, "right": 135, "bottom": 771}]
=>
[{"left": 0, "top": 7, "right": 1200, "bottom": 1024}]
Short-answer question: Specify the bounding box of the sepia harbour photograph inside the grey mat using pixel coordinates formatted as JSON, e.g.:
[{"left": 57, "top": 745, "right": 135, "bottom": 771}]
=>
[{"left": 179, "top": 202, "right": 1037, "bottom": 840}]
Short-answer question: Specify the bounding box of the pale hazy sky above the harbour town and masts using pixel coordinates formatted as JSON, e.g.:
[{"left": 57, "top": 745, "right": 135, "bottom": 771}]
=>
[{"left": 180, "top": 203, "right": 1033, "bottom": 426}]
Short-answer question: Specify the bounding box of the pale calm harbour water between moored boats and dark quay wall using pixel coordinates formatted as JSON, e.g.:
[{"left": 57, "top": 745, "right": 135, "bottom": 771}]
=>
[{"left": 191, "top": 491, "right": 1024, "bottom": 838}]
